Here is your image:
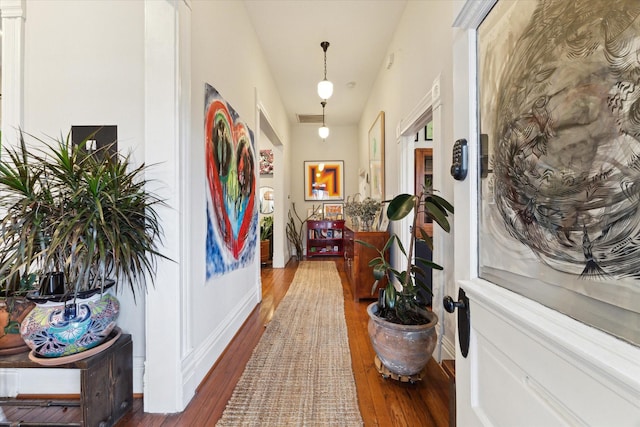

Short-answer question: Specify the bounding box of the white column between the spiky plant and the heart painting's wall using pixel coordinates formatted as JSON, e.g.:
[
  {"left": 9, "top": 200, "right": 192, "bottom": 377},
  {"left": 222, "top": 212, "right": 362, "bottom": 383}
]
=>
[{"left": 144, "top": 0, "right": 193, "bottom": 413}]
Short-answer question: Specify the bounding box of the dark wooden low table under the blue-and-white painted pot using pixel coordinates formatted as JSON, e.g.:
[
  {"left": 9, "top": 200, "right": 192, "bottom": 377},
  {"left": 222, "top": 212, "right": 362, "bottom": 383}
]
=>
[{"left": 0, "top": 334, "right": 133, "bottom": 427}]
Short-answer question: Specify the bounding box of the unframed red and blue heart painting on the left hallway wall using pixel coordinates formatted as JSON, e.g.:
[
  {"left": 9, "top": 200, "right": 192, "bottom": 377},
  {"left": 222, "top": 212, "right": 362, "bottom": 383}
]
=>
[{"left": 204, "top": 84, "right": 258, "bottom": 279}]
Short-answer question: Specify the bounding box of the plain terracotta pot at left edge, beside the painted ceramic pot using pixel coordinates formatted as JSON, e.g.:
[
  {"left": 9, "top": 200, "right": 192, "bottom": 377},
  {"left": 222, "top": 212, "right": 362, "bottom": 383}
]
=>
[{"left": 0, "top": 297, "right": 35, "bottom": 356}]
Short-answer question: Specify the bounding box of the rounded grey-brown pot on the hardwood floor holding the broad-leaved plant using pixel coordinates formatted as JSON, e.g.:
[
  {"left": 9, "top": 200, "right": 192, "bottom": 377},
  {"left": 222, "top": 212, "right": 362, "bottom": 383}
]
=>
[{"left": 367, "top": 302, "right": 438, "bottom": 376}]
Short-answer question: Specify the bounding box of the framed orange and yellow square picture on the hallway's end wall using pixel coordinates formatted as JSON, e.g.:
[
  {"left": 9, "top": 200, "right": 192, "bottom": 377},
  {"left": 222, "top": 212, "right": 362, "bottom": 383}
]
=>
[{"left": 304, "top": 160, "right": 344, "bottom": 200}]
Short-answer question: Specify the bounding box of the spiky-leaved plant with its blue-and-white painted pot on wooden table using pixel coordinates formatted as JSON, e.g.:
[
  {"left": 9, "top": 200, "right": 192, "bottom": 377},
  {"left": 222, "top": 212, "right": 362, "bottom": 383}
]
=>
[{"left": 0, "top": 134, "right": 162, "bottom": 357}]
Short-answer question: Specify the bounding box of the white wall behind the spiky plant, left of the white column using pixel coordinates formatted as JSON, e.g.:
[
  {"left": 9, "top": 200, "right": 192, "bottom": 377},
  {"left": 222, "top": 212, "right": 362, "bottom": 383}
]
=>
[{"left": 0, "top": 1, "right": 145, "bottom": 393}]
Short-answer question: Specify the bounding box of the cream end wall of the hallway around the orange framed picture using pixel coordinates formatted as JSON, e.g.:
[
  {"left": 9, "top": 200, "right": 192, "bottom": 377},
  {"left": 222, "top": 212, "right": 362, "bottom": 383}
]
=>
[{"left": 287, "top": 123, "right": 359, "bottom": 256}]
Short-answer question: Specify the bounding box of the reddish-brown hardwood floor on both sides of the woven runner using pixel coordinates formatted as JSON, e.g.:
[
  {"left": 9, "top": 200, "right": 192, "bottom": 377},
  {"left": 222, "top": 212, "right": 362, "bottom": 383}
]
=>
[{"left": 2, "top": 258, "right": 450, "bottom": 427}]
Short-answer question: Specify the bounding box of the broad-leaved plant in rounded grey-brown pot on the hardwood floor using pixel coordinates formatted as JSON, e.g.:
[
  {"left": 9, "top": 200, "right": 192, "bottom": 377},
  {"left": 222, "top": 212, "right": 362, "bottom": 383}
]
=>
[{"left": 358, "top": 183, "right": 453, "bottom": 377}]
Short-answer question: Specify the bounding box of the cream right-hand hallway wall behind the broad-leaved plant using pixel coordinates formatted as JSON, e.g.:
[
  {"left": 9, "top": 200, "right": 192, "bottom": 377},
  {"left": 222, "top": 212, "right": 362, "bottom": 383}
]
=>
[{"left": 358, "top": 0, "right": 460, "bottom": 358}]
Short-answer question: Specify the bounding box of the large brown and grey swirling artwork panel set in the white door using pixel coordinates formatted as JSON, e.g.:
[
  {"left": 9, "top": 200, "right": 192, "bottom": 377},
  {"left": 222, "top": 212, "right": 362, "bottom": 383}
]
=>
[{"left": 478, "top": 0, "right": 640, "bottom": 345}]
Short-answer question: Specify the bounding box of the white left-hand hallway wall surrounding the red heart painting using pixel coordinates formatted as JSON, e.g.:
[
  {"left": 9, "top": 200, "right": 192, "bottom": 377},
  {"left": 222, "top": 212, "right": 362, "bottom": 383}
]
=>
[{"left": 183, "top": 1, "right": 289, "bottom": 414}]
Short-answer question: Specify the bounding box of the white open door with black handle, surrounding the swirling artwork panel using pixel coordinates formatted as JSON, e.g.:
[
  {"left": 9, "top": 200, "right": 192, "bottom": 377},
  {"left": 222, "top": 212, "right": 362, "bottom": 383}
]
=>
[{"left": 448, "top": 0, "right": 640, "bottom": 427}]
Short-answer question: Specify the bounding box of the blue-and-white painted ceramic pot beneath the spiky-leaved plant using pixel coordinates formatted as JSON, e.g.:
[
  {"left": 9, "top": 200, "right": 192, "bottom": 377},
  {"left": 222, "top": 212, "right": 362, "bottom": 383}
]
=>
[{"left": 20, "top": 289, "right": 120, "bottom": 357}]
